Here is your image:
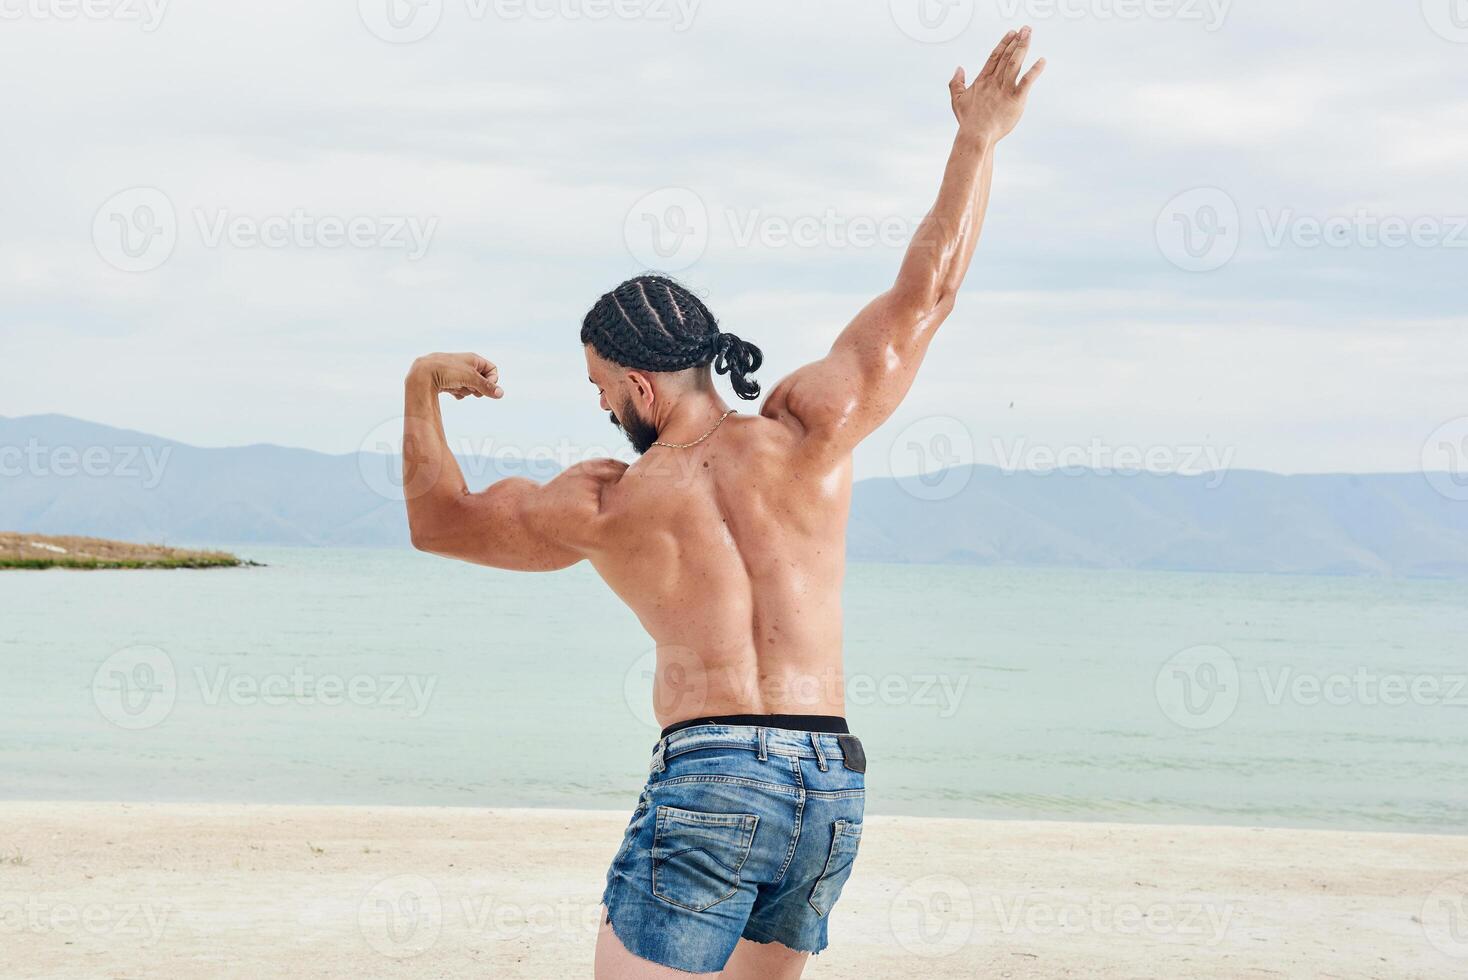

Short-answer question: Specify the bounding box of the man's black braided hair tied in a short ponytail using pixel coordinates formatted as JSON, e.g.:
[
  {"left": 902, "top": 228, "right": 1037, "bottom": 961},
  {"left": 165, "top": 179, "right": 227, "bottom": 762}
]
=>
[{"left": 581, "top": 276, "right": 765, "bottom": 399}]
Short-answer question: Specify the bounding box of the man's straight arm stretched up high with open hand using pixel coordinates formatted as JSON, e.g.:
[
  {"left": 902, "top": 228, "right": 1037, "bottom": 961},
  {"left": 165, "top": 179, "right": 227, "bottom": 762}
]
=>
[{"left": 763, "top": 28, "right": 1045, "bottom": 453}]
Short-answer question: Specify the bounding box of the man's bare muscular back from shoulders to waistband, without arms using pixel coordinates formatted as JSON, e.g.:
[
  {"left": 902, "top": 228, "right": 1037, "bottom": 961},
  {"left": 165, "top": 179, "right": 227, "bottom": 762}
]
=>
[{"left": 592, "top": 415, "right": 851, "bottom": 725}]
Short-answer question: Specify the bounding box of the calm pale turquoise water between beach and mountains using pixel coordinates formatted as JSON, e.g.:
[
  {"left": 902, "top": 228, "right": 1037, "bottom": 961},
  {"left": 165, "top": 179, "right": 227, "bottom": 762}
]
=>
[{"left": 0, "top": 547, "right": 1468, "bottom": 832}]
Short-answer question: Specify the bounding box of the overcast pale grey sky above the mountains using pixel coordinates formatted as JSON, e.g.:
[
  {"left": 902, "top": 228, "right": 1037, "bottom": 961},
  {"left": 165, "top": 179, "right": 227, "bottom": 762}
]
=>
[{"left": 0, "top": 0, "right": 1468, "bottom": 475}]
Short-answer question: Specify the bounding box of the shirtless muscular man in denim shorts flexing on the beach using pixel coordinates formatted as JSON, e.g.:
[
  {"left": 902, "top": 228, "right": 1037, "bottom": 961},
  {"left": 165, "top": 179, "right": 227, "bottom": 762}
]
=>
[{"left": 404, "top": 28, "right": 1044, "bottom": 980}]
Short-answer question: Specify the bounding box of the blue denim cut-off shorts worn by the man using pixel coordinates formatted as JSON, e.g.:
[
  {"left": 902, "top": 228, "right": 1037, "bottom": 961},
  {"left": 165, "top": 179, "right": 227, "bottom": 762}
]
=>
[{"left": 602, "top": 725, "right": 866, "bottom": 973}]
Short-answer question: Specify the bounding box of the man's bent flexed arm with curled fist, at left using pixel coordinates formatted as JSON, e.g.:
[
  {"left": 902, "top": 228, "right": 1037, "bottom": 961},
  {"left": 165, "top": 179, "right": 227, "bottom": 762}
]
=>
[{"left": 402, "top": 354, "right": 627, "bottom": 572}]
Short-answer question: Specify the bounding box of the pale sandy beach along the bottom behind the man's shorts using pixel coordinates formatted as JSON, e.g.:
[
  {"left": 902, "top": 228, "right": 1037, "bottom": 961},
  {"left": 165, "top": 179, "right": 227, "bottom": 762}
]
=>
[{"left": 0, "top": 802, "right": 1468, "bottom": 977}]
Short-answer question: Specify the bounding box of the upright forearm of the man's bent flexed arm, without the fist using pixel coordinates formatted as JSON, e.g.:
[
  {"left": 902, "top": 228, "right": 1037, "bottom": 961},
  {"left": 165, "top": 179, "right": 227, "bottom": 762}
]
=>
[{"left": 402, "top": 362, "right": 468, "bottom": 543}]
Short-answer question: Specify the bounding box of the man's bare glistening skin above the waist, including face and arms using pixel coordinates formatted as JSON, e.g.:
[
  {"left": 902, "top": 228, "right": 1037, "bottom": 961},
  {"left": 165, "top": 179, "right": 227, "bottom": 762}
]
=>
[{"left": 404, "top": 28, "right": 1044, "bottom": 725}]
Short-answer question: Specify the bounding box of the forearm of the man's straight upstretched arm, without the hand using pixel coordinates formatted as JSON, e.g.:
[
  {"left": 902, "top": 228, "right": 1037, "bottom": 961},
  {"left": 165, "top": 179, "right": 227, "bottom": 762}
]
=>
[{"left": 893, "top": 128, "right": 995, "bottom": 320}]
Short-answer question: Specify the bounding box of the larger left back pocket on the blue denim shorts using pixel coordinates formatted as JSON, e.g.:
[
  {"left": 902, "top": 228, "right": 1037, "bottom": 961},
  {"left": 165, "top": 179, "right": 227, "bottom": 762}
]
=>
[{"left": 652, "top": 807, "right": 759, "bottom": 913}]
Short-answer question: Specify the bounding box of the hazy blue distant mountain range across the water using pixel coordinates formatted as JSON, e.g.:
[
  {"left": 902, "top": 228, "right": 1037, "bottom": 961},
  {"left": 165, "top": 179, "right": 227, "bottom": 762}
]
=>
[{"left": 0, "top": 415, "right": 1468, "bottom": 577}]
